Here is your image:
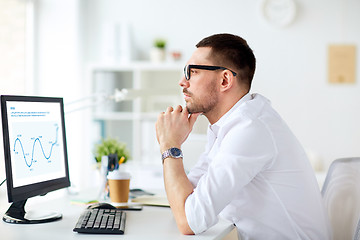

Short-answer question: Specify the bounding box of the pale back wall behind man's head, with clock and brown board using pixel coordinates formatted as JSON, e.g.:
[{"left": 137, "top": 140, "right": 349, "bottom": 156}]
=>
[{"left": 82, "top": 0, "right": 360, "bottom": 171}]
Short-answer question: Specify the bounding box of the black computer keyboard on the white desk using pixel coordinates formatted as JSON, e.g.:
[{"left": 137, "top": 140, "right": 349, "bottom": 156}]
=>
[{"left": 73, "top": 208, "right": 126, "bottom": 234}]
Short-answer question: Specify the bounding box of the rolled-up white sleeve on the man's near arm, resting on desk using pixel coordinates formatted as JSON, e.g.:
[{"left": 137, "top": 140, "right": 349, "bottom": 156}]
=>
[{"left": 185, "top": 120, "right": 276, "bottom": 234}]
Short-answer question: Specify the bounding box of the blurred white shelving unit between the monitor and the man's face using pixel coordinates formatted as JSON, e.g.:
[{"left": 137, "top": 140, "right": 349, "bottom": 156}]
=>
[{"left": 88, "top": 62, "right": 183, "bottom": 163}]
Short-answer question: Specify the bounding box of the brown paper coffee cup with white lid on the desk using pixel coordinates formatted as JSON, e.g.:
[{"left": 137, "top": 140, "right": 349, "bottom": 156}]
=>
[{"left": 107, "top": 170, "right": 130, "bottom": 203}]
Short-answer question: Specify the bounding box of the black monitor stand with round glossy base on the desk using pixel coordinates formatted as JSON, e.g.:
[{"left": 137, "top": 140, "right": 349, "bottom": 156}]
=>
[{"left": 3, "top": 199, "right": 62, "bottom": 224}]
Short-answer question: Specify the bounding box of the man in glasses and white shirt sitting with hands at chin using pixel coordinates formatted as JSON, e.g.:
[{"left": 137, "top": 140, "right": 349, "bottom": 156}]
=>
[{"left": 156, "top": 34, "right": 330, "bottom": 239}]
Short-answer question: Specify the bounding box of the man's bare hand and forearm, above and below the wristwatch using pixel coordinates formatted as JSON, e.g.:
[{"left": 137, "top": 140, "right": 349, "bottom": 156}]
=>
[{"left": 156, "top": 106, "right": 200, "bottom": 234}]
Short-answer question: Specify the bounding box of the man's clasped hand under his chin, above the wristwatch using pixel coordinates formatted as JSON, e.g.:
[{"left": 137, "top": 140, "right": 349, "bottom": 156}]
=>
[{"left": 156, "top": 105, "right": 200, "bottom": 152}]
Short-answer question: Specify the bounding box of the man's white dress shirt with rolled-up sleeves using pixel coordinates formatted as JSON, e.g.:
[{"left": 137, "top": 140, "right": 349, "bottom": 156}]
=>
[{"left": 185, "top": 94, "right": 330, "bottom": 240}]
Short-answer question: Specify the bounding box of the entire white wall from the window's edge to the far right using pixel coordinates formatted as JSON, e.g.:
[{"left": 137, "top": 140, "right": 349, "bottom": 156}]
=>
[{"left": 31, "top": 0, "right": 360, "bottom": 189}]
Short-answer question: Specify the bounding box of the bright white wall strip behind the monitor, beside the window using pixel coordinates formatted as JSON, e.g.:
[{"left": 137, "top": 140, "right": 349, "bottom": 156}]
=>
[{"left": 34, "top": 0, "right": 92, "bottom": 187}]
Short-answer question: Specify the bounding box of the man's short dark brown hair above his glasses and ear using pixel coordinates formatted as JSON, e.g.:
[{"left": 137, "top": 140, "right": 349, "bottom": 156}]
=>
[{"left": 196, "top": 33, "right": 256, "bottom": 90}]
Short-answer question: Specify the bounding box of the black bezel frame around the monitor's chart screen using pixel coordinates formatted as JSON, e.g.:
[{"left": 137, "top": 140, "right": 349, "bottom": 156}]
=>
[{"left": 1, "top": 95, "right": 70, "bottom": 202}]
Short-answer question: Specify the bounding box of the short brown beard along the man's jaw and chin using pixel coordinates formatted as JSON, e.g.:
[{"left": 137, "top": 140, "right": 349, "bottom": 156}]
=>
[{"left": 183, "top": 85, "right": 218, "bottom": 114}]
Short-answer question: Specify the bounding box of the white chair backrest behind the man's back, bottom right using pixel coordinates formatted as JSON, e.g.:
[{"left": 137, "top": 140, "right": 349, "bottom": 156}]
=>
[{"left": 321, "top": 157, "right": 360, "bottom": 240}]
